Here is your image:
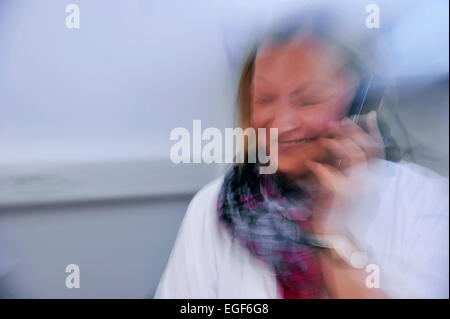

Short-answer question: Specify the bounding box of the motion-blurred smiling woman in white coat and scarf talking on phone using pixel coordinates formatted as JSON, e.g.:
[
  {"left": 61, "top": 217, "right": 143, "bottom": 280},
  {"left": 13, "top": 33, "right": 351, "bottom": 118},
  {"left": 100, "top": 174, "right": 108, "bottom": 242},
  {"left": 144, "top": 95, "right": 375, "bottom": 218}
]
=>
[{"left": 156, "top": 20, "right": 448, "bottom": 298}]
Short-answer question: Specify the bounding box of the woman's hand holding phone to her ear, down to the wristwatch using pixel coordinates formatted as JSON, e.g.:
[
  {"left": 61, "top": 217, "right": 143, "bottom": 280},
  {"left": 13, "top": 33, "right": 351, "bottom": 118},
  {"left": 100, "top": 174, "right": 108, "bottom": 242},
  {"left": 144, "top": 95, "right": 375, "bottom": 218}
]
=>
[{"left": 306, "top": 111, "right": 385, "bottom": 234}]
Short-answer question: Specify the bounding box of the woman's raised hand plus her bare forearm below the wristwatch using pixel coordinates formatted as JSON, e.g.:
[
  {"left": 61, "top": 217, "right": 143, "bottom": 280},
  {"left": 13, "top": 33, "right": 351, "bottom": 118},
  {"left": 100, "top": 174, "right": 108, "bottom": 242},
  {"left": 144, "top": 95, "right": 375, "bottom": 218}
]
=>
[{"left": 307, "top": 112, "right": 387, "bottom": 299}]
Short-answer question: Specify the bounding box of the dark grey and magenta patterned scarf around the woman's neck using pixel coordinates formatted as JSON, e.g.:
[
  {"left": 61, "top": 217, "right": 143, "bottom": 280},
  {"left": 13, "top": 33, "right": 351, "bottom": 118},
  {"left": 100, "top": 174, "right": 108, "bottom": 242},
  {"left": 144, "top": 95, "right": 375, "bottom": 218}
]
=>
[{"left": 217, "top": 164, "right": 324, "bottom": 298}]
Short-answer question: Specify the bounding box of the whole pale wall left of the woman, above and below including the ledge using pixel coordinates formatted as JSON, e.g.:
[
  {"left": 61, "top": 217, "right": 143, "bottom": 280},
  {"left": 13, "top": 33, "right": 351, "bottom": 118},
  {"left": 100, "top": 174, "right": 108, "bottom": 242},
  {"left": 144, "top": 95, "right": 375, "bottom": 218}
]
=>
[{"left": 0, "top": 0, "right": 235, "bottom": 298}]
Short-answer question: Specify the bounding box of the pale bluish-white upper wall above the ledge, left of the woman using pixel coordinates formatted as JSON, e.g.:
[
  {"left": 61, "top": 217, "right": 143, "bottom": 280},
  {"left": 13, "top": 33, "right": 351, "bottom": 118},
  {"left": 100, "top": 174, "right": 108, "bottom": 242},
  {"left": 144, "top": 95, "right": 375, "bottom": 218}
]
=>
[{"left": 0, "top": 0, "right": 235, "bottom": 164}]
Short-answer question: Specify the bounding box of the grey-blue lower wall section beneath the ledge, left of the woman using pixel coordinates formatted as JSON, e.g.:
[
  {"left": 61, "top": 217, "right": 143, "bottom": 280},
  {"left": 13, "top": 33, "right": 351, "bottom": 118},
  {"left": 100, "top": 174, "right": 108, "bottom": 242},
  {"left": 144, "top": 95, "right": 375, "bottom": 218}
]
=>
[{"left": 0, "top": 196, "right": 190, "bottom": 298}]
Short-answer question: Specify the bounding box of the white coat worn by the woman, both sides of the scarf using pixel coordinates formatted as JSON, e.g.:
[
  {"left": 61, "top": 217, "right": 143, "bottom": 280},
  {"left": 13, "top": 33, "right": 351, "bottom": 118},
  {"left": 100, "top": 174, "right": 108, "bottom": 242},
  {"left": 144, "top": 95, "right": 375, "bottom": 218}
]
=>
[{"left": 155, "top": 161, "right": 449, "bottom": 298}]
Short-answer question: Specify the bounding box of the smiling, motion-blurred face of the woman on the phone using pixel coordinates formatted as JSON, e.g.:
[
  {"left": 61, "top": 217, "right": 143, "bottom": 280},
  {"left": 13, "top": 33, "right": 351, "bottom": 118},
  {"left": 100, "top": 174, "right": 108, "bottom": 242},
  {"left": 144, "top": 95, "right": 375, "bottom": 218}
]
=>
[{"left": 251, "top": 39, "right": 355, "bottom": 177}]
